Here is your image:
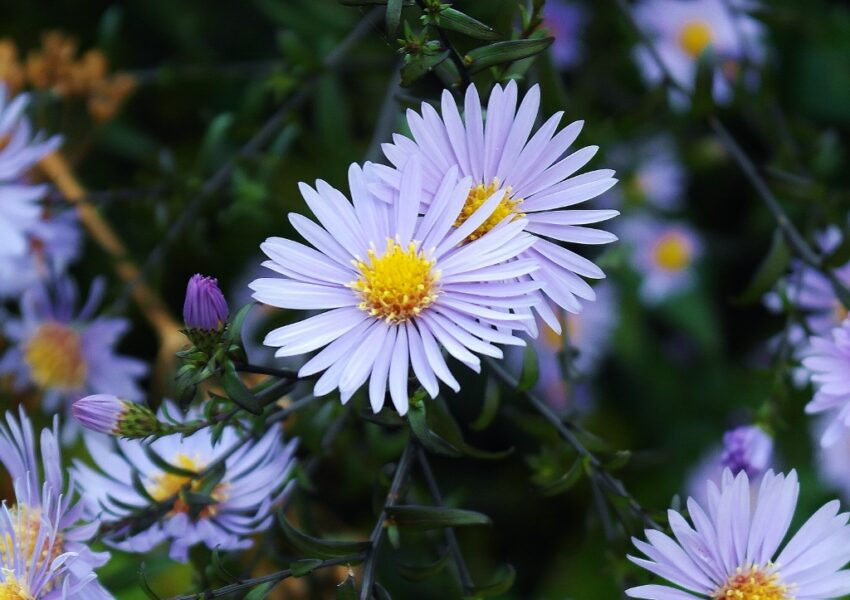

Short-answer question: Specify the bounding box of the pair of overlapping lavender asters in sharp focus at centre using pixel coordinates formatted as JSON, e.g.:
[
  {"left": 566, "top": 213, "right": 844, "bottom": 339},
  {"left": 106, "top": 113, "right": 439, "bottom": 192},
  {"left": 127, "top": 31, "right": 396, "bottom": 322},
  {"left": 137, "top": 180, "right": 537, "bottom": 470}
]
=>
[{"left": 250, "top": 82, "right": 617, "bottom": 414}]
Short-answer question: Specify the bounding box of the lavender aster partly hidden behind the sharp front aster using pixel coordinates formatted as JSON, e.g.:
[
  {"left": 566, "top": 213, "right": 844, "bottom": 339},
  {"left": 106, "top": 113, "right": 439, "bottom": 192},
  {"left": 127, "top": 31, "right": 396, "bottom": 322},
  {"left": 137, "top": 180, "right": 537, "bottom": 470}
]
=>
[{"left": 371, "top": 81, "right": 618, "bottom": 331}]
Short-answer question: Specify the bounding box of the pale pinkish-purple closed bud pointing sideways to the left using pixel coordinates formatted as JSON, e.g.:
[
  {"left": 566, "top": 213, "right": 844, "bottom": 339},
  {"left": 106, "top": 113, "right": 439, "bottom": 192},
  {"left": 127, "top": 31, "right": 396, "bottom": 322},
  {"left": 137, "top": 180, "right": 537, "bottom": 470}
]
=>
[{"left": 71, "top": 394, "right": 160, "bottom": 438}]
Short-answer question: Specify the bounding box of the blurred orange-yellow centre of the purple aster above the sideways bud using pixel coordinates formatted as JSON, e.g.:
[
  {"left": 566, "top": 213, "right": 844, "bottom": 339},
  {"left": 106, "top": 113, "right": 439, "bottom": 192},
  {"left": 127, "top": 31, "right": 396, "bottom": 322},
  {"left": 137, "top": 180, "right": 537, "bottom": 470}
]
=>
[{"left": 24, "top": 322, "right": 88, "bottom": 391}]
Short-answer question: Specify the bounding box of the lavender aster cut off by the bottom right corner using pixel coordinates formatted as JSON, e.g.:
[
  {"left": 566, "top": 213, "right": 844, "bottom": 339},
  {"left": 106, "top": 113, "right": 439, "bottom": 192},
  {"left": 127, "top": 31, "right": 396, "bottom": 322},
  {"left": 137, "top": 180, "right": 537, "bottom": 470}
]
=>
[{"left": 626, "top": 470, "right": 850, "bottom": 600}]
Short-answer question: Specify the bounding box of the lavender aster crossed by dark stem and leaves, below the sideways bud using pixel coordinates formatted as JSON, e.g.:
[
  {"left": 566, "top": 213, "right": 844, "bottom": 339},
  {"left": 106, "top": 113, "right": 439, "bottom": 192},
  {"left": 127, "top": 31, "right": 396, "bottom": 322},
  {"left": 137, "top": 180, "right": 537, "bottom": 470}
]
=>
[{"left": 74, "top": 402, "right": 297, "bottom": 562}]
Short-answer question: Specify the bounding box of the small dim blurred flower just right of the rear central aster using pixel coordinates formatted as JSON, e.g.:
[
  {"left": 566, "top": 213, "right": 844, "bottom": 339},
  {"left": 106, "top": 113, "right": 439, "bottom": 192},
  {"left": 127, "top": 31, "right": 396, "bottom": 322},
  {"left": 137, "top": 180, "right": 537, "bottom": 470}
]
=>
[{"left": 607, "top": 136, "right": 685, "bottom": 210}]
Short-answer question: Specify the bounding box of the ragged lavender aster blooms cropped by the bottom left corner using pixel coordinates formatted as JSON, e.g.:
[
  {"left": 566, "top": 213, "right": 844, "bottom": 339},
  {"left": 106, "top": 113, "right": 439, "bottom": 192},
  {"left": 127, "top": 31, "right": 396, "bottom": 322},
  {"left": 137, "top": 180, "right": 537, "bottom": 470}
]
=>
[{"left": 0, "top": 408, "right": 112, "bottom": 600}]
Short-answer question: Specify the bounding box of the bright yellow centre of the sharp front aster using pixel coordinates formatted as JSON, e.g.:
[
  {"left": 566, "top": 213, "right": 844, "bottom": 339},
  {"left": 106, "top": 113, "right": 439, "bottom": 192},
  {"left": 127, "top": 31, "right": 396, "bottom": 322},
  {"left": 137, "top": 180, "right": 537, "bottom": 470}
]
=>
[{"left": 348, "top": 239, "right": 440, "bottom": 324}]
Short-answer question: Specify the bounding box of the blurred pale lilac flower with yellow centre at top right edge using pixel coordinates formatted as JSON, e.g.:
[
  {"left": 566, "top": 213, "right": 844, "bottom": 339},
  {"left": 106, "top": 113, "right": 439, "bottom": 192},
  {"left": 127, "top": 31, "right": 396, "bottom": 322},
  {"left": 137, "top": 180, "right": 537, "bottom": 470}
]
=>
[{"left": 635, "top": 0, "right": 765, "bottom": 105}]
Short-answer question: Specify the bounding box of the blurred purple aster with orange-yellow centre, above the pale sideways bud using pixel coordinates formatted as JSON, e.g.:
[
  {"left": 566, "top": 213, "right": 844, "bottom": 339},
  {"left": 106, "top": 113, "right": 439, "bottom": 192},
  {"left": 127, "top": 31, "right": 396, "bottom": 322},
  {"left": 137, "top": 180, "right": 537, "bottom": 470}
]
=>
[{"left": 0, "top": 278, "right": 147, "bottom": 411}]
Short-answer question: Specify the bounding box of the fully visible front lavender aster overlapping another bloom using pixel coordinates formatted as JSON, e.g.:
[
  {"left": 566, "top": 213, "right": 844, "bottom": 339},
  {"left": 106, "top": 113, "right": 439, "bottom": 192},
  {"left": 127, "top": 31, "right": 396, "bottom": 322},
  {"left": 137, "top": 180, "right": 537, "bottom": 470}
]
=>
[{"left": 250, "top": 160, "right": 539, "bottom": 414}]
